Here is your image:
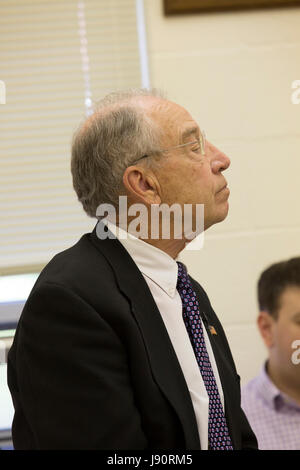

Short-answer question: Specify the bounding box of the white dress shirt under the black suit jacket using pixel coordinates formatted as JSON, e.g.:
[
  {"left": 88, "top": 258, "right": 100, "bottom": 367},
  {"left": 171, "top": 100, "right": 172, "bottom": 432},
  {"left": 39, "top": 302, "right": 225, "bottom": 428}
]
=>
[{"left": 102, "top": 219, "right": 224, "bottom": 450}]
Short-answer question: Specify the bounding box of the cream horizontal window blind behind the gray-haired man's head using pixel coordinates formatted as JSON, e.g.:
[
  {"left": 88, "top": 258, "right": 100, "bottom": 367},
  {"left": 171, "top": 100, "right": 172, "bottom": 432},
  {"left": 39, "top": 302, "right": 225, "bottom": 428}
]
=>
[{"left": 0, "top": 0, "right": 145, "bottom": 274}]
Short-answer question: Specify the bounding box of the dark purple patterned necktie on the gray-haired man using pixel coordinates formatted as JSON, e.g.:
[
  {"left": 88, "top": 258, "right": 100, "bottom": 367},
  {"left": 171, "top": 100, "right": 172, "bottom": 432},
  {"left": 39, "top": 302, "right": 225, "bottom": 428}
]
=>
[{"left": 177, "top": 261, "right": 233, "bottom": 450}]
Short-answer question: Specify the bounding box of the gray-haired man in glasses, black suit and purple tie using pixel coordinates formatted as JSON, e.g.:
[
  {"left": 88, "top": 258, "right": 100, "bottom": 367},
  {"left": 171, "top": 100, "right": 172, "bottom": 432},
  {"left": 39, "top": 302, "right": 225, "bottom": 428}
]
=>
[{"left": 8, "top": 90, "right": 257, "bottom": 450}]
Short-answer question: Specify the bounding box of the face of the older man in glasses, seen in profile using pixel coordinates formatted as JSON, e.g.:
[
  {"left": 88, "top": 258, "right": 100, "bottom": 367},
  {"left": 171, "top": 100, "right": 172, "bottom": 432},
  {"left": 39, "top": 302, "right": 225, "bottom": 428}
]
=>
[{"left": 151, "top": 102, "right": 230, "bottom": 229}]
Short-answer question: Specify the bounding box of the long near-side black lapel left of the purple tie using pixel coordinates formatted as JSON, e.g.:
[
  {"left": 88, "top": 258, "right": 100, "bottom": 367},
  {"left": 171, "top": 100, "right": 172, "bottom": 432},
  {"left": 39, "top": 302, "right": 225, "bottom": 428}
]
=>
[{"left": 91, "top": 228, "right": 200, "bottom": 449}]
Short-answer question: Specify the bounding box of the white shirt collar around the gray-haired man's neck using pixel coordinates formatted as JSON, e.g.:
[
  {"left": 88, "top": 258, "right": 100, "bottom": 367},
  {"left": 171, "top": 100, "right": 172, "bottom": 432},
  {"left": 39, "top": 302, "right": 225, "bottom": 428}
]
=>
[{"left": 101, "top": 219, "right": 179, "bottom": 298}]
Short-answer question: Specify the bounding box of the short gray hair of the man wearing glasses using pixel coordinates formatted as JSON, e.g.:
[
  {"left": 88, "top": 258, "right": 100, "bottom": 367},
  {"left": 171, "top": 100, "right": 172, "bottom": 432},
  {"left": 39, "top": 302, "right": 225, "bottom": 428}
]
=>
[{"left": 71, "top": 89, "right": 164, "bottom": 217}]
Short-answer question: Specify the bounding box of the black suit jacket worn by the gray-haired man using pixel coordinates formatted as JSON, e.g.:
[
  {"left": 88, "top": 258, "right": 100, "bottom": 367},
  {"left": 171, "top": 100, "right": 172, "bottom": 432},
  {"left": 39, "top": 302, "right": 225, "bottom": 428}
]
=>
[{"left": 8, "top": 224, "right": 257, "bottom": 450}]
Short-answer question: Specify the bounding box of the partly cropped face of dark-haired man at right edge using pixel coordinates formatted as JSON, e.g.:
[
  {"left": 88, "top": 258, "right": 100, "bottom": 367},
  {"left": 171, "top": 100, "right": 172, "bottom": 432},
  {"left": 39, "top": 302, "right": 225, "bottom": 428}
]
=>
[{"left": 270, "top": 286, "right": 300, "bottom": 387}]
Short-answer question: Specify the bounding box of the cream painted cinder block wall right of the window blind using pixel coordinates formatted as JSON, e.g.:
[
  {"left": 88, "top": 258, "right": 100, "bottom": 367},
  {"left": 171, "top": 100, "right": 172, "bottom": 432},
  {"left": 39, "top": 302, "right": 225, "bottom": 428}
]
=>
[{"left": 145, "top": 0, "right": 300, "bottom": 384}]
